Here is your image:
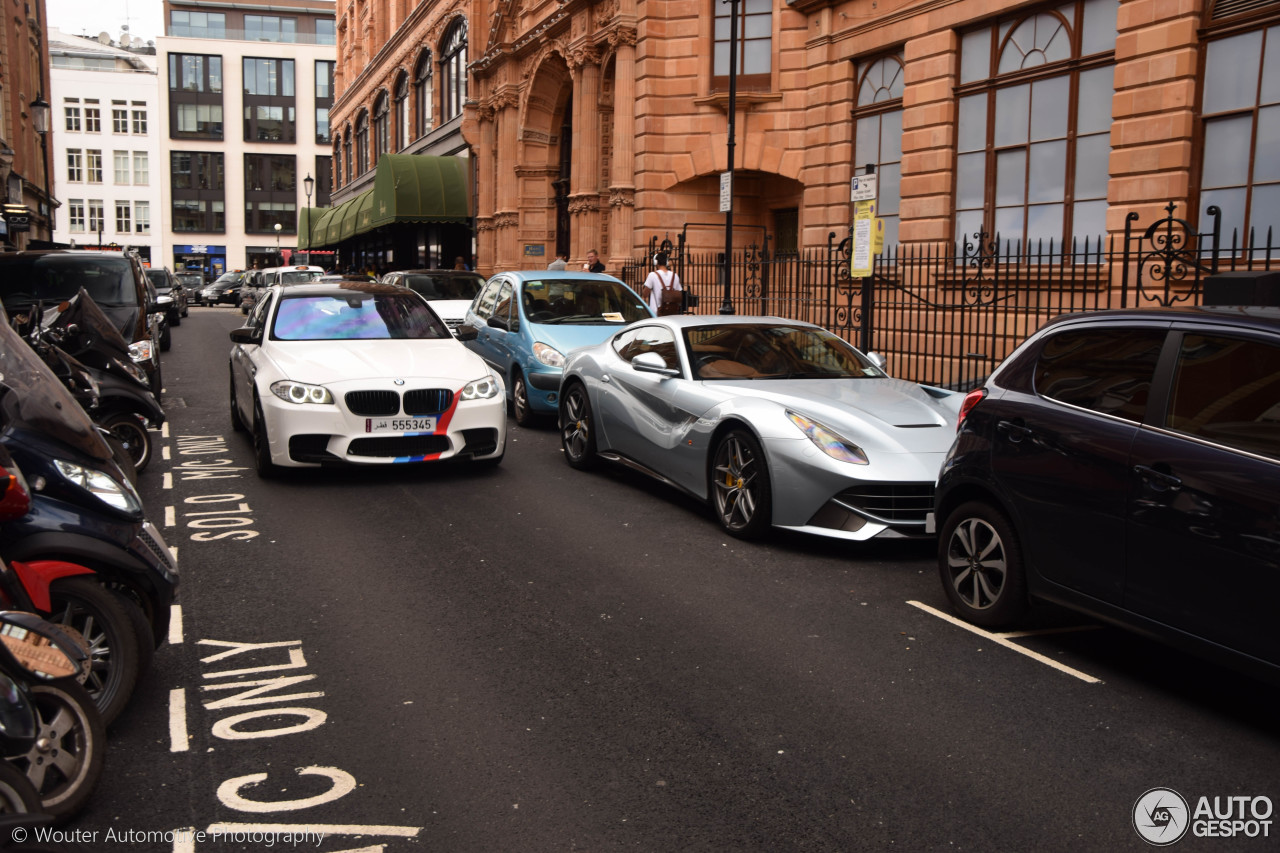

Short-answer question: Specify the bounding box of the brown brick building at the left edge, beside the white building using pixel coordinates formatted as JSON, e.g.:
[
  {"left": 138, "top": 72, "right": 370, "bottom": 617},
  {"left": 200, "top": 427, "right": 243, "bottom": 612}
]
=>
[{"left": 0, "top": 0, "right": 58, "bottom": 251}]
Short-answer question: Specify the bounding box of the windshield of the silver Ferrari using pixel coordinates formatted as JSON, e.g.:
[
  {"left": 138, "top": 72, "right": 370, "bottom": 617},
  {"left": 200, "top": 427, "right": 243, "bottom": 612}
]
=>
[{"left": 685, "top": 323, "right": 886, "bottom": 379}]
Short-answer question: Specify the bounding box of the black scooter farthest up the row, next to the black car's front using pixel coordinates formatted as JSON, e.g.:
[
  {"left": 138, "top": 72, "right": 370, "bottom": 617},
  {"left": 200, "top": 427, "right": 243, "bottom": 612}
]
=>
[{"left": 20, "top": 288, "right": 165, "bottom": 474}]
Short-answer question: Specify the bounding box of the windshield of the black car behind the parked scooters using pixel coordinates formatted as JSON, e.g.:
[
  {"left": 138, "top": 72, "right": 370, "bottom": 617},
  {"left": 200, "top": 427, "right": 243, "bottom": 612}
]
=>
[{"left": 0, "top": 255, "right": 138, "bottom": 310}]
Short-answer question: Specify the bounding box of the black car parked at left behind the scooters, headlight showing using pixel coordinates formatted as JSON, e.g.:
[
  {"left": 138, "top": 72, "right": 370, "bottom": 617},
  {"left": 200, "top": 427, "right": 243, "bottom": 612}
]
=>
[{"left": 0, "top": 250, "right": 166, "bottom": 397}]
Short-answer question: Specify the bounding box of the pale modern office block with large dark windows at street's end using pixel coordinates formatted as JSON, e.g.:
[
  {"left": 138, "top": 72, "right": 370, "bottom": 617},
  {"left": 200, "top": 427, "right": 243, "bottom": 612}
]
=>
[{"left": 156, "top": 0, "right": 335, "bottom": 277}]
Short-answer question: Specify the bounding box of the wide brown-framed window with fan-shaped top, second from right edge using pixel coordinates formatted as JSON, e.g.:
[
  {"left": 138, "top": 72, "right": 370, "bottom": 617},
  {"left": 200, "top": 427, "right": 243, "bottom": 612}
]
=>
[{"left": 955, "top": 0, "right": 1119, "bottom": 245}]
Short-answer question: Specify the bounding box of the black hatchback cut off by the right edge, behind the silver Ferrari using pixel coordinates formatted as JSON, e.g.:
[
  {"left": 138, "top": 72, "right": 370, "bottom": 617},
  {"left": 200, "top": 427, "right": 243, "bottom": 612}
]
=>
[{"left": 936, "top": 307, "right": 1280, "bottom": 680}]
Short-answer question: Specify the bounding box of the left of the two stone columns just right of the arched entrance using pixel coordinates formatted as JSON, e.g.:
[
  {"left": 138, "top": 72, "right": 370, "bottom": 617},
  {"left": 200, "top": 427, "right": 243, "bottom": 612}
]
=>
[{"left": 568, "top": 45, "right": 600, "bottom": 261}]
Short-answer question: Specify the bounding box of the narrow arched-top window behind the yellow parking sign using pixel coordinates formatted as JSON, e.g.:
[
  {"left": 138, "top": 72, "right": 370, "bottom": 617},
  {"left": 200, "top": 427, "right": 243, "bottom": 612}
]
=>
[{"left": 854, "top": 50, "right": 904, "bottom": 243}]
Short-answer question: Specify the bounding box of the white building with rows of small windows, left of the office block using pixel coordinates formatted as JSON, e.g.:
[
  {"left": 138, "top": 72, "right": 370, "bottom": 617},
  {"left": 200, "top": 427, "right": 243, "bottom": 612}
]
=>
[{"left": 49, "top": 28, "right": 169, "bottom": 266}]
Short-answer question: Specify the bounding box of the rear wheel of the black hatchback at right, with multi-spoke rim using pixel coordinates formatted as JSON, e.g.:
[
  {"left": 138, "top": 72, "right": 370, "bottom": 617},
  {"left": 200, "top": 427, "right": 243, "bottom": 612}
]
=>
[{"left": 938, "top": 501, "right": 1027, "bottom": 628}]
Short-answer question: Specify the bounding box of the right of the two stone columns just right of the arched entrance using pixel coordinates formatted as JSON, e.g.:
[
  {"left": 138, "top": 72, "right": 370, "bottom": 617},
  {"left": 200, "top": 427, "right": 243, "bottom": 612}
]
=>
[{"left": 605, "top": 27, "right": 636, "bottom": 270}]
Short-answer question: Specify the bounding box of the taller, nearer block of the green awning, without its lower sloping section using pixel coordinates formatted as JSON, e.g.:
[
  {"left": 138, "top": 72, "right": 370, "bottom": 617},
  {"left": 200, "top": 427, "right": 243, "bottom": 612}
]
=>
[{"left": 370, "top": 154, "right": 471, "bottom": 228}]
